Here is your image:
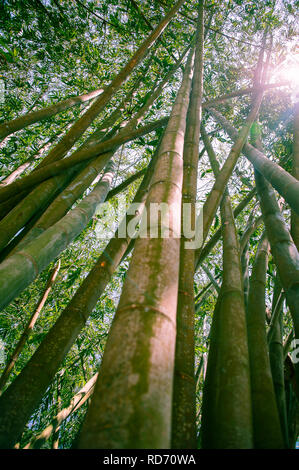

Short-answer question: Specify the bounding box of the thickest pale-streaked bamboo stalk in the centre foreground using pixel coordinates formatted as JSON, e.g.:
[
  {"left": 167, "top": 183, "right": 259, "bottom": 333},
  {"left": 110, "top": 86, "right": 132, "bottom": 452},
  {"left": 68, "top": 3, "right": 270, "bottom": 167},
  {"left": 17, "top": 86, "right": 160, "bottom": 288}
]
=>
[{"left": 78, "top": 46, "right": 197, "bottom": 448}]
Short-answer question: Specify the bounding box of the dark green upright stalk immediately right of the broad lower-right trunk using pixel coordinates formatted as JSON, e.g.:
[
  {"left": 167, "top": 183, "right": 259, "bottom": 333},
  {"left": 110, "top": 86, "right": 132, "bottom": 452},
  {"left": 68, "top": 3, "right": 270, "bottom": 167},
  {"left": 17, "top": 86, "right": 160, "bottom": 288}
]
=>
[{"left": 247, "top": 235, "right": 284, "bottom": 449}]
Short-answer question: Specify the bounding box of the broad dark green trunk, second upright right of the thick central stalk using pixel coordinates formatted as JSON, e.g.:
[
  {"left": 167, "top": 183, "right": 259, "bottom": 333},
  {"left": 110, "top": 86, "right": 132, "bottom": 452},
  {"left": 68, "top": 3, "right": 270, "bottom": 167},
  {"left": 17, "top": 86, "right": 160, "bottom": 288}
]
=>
[{"left": 202, "top": 190, "right": 253, "bottom": 449}]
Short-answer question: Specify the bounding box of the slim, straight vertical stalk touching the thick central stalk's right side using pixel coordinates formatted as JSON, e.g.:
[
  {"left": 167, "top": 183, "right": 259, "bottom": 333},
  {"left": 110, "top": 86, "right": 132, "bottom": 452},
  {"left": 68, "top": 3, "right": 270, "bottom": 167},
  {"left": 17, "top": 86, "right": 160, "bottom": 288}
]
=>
[{"left": 171, "top": 0, "right": 204, "bottom": 449}]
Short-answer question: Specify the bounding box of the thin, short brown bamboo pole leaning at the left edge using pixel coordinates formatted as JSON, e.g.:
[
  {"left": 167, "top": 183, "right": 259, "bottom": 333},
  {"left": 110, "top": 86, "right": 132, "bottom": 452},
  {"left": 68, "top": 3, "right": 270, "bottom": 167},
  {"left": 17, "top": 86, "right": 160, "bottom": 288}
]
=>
[{"left": 0, "top": 261, "right": 60, "bottom": 394}]
